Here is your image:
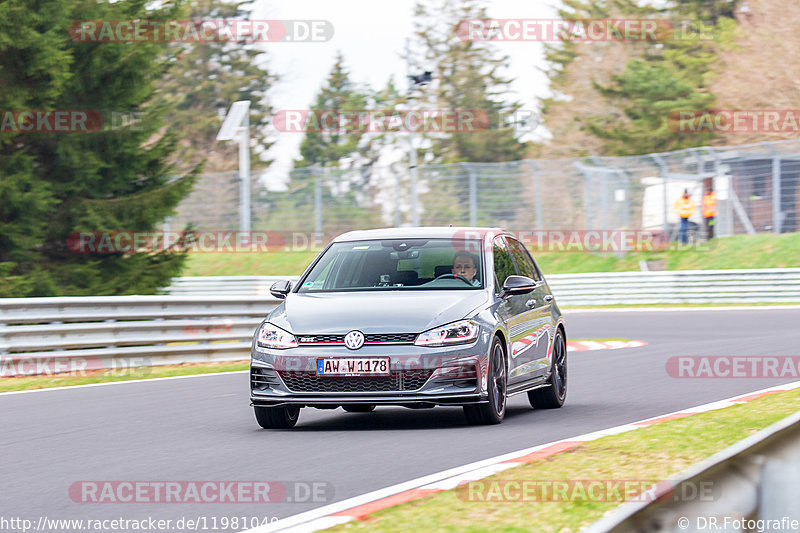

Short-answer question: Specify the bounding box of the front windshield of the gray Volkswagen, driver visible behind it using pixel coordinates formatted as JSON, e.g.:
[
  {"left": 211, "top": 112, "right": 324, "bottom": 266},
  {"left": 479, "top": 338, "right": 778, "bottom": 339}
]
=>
[{"left": 297, "top": 239, "right": 484, "bottom": 292}]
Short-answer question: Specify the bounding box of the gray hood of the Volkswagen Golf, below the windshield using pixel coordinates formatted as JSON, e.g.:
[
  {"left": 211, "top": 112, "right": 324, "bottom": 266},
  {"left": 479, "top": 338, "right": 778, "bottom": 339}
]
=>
[{"left": 268, "top": 290, "right": 488, "bottom": 334}]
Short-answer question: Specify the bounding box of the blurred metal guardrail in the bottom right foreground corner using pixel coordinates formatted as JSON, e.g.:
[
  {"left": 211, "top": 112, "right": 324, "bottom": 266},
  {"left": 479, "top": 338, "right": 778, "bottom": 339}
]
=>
[{"left": 584, "top": 411, "right": 800, "bottom": 533}]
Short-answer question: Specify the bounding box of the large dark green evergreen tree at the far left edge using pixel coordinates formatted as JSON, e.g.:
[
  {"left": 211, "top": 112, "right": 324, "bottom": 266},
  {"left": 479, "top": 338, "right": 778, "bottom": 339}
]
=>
[{"left": 0, "top": 0, "right": 194, "bottom": 297}]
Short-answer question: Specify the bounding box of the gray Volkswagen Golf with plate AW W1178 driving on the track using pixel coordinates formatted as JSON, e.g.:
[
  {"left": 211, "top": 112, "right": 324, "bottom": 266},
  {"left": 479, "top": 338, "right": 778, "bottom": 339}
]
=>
[{"left": 250, "top": 227, "right": 567, "bottom": 428}]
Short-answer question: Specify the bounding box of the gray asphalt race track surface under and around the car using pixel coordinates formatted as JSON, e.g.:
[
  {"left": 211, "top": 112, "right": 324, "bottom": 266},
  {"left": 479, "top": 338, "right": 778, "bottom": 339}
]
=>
[{"left": 0, "top": 308, "right": 800, "bottom": 531}]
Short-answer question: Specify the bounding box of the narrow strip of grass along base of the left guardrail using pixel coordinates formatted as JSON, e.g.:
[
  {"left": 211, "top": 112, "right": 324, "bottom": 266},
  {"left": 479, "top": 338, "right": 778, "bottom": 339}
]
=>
[{"left": 0, "top": 361, "right": 250, "bottom": 392}]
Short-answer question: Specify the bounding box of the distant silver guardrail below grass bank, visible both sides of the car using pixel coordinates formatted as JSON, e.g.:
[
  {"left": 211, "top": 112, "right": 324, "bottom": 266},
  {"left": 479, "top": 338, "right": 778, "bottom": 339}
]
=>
[{"left": 167, "top": 268, "right": 800, "bottom": 305}]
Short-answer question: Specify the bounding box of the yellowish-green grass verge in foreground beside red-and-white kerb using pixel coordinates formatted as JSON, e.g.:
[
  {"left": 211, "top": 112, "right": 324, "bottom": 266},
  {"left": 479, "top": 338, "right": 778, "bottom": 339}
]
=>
[{"left": 326, "top": 389, "right": 800, "bottom": 533}]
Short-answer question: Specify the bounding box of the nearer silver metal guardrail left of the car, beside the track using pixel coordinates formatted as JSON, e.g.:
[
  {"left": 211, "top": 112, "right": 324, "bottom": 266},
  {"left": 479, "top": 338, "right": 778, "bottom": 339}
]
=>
[{"left": 0, "top": 295, "right": 278, "bottom": 376}]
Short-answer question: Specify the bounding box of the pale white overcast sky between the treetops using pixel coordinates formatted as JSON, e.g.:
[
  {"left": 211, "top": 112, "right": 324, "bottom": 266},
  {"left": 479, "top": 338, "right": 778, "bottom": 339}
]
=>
[{"left": 253, "top": 0, "right": 558, "bottom": 183}]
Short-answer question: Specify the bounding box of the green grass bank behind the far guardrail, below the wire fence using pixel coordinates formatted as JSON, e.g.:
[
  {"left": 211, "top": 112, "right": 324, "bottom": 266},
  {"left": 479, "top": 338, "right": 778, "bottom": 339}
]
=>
[{"left": 183, "top": 233, "right": 800, "bottom": 276}]
